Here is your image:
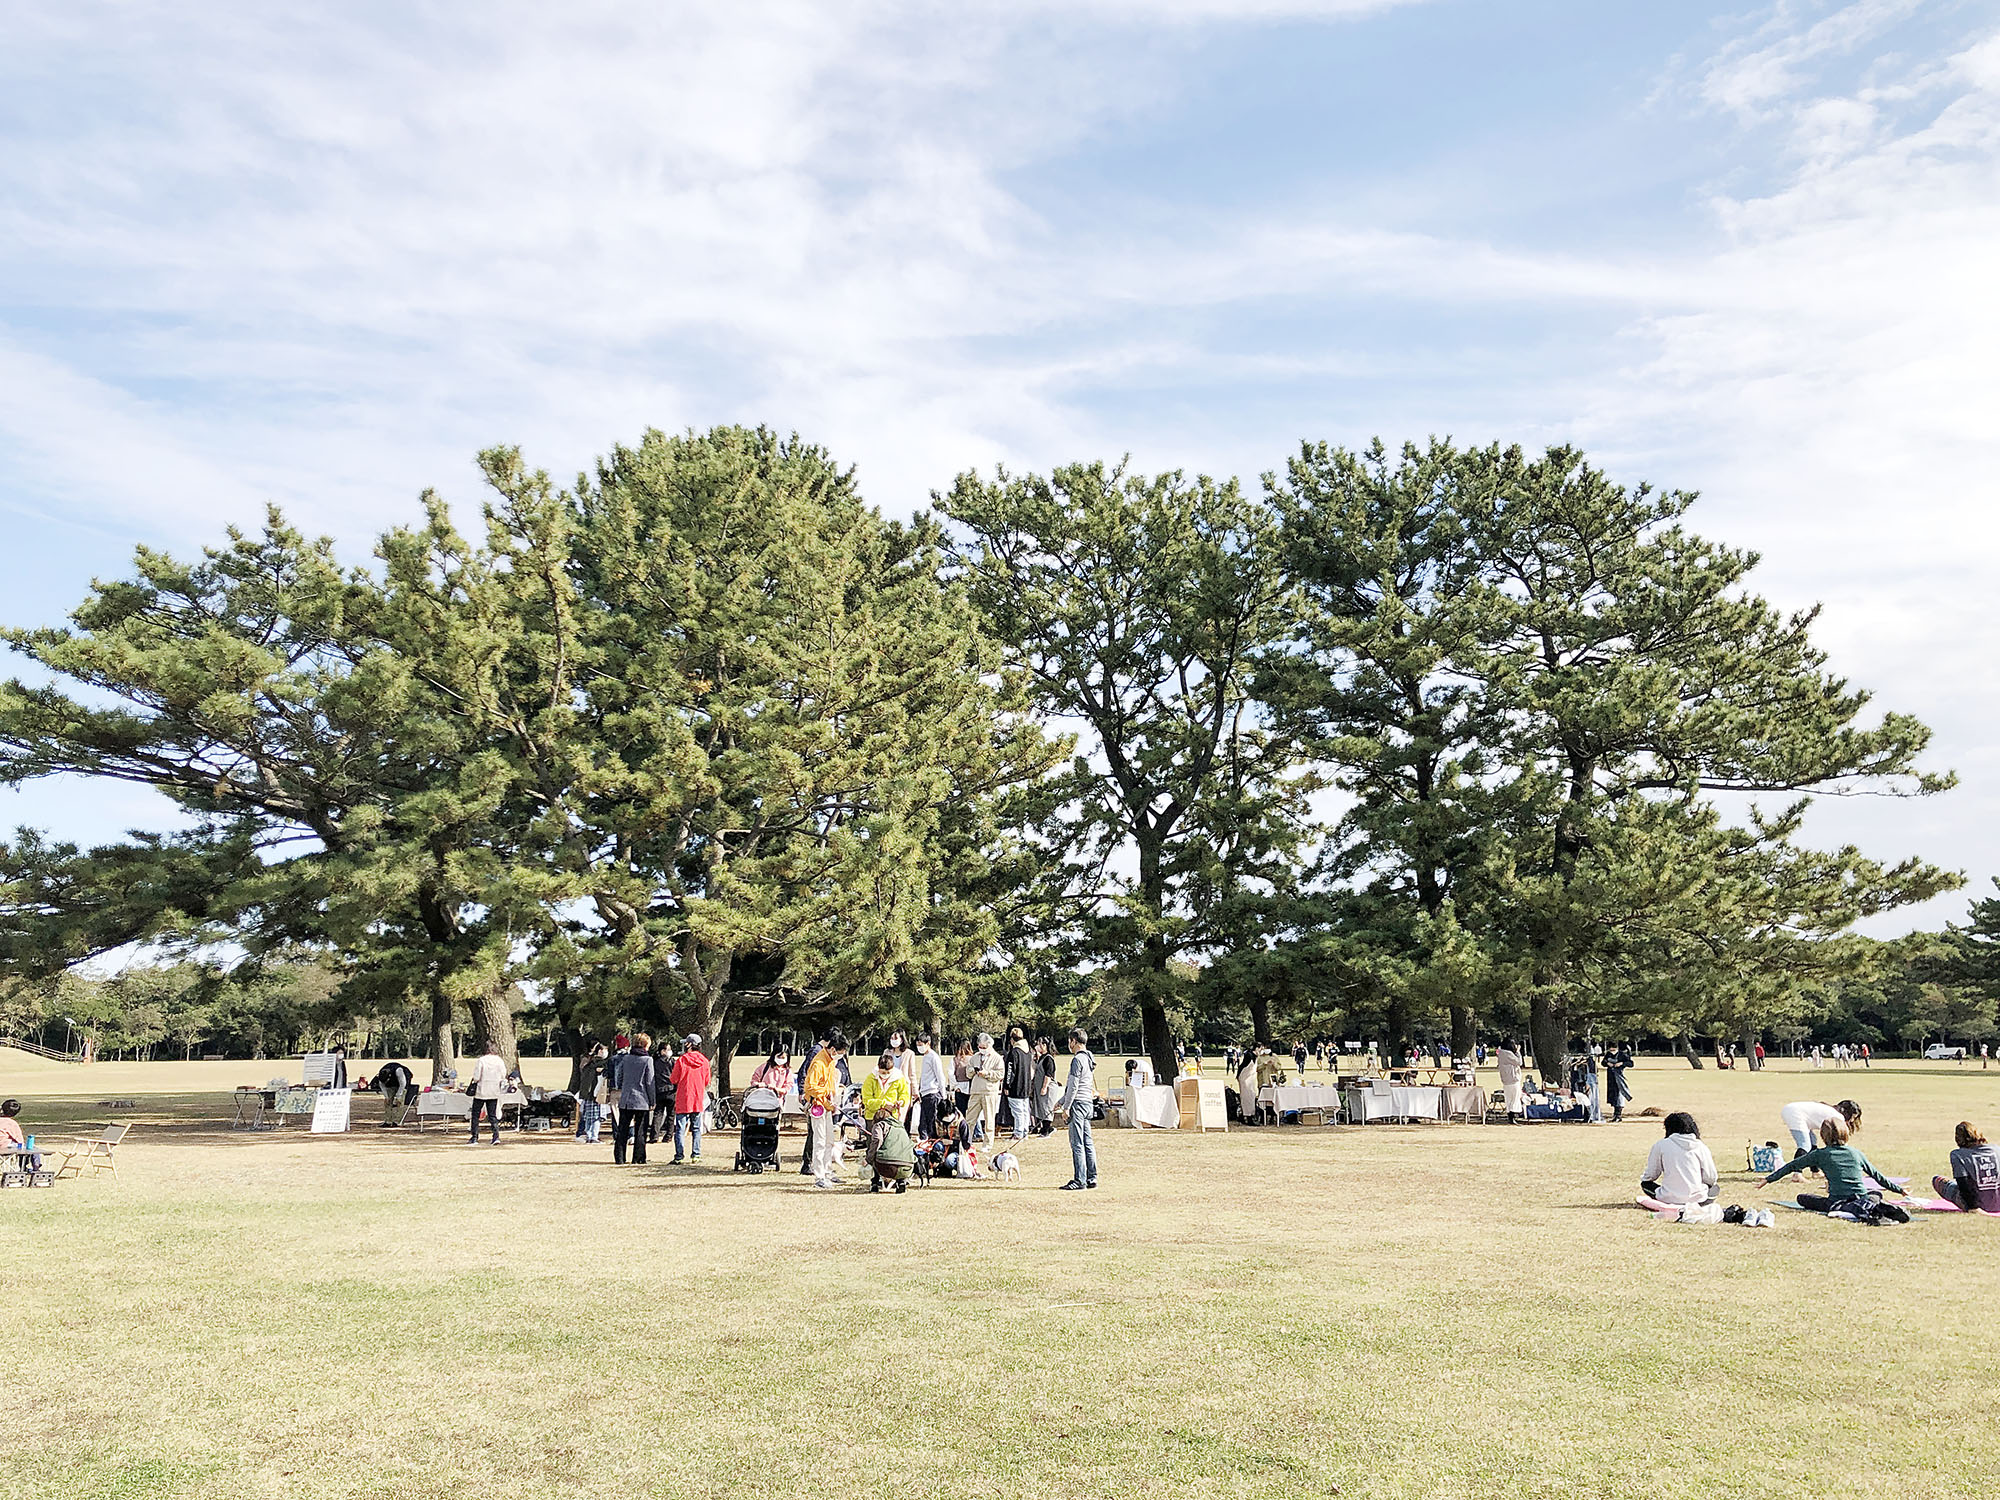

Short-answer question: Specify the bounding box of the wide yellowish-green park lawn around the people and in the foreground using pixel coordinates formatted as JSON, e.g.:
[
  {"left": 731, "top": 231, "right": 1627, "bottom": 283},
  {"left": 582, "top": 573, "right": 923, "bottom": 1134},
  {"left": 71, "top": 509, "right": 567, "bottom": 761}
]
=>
[{"left": 0, "top": 1062, "right": 2000, "bottom": 1500}]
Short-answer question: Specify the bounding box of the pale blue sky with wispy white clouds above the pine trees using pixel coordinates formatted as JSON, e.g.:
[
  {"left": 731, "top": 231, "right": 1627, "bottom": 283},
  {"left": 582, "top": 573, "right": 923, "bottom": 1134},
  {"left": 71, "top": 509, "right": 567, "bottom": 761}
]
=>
[{"left": 0, "top": 0, "right": 2000, "bottom": 930}]
